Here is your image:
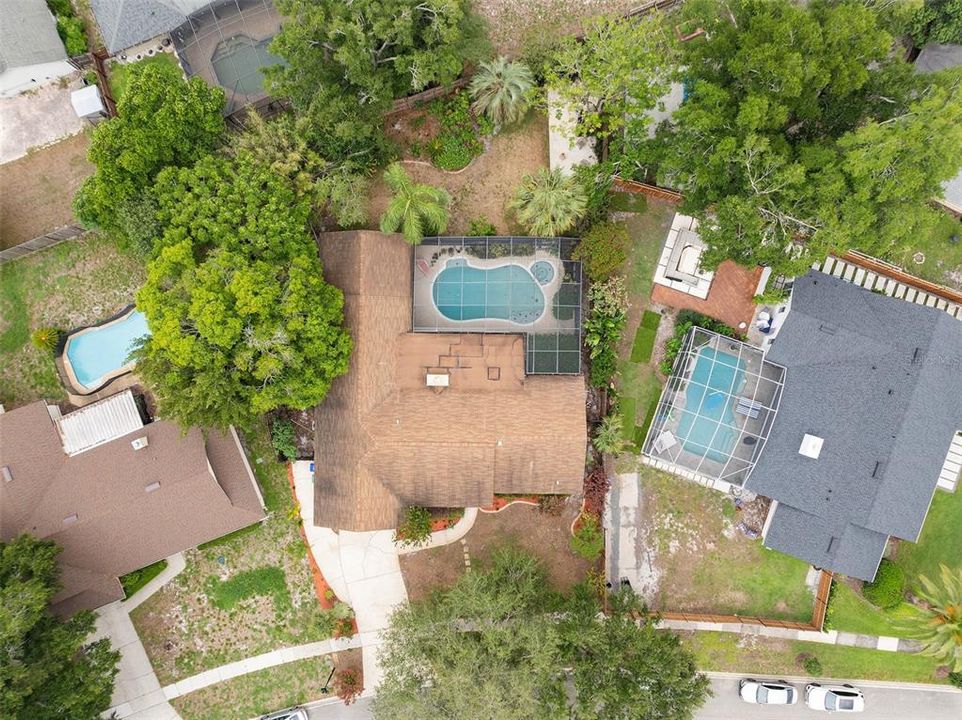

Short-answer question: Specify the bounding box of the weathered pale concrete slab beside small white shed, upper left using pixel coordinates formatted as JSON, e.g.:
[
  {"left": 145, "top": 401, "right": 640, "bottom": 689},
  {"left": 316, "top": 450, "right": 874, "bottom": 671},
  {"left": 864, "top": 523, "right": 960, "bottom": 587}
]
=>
[{"left": 0, "top": 72, "right": 87, "bottom": 163}]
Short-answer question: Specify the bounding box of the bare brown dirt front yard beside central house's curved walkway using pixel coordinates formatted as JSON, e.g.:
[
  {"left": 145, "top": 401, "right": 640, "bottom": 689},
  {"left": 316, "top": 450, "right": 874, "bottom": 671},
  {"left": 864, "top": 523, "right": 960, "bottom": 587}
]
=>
[{"left": 401, "top": 496, "right": 592, "bottom": 600}]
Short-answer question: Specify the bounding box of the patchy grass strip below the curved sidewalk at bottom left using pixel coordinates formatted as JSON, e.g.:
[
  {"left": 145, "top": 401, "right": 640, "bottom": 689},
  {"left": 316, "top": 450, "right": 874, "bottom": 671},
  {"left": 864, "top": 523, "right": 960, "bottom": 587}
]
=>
[{"left": 170, "top": 657, "right": 332, "bottom": 720}]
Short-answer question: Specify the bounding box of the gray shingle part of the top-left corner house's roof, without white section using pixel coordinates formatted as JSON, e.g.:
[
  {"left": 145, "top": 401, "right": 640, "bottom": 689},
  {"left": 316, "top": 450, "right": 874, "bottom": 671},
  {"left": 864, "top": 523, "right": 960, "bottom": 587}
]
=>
[{"left": 0, "top": 0, "right": 67, "bottom": 72}]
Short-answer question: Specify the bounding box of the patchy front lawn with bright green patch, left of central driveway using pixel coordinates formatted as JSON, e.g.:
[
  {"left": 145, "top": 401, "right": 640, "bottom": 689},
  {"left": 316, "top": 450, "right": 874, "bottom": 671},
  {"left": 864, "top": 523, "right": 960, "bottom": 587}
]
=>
[{"left": 125, "top": 425, "right": 334, "bottom": 685}]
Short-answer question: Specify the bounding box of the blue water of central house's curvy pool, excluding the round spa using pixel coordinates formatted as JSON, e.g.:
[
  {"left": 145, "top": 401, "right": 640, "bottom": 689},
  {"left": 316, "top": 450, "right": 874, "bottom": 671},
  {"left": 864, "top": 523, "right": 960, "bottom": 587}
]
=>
[{"left": 431, "top": 258, "right": 545, "bottom": 325}]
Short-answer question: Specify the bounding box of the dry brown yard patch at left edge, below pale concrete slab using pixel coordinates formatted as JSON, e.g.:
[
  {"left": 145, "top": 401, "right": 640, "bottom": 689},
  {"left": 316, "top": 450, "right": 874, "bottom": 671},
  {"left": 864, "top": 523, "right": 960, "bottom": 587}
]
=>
[{"left": 0, "top": 133, "right": 94, "bottom": 249}]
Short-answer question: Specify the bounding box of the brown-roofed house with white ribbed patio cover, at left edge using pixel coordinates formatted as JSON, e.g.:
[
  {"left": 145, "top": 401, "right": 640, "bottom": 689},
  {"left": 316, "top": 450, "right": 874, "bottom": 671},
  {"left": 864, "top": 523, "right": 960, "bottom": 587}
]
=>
[{"left": 0, "top": 390, "right": 264, "bottom": 614}]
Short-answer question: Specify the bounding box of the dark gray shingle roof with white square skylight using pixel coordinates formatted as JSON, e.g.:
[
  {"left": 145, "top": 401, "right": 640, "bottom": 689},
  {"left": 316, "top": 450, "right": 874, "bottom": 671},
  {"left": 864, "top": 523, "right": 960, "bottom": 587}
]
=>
[{"left": 746, "top": 272, "right": 962, "bottom": 579}]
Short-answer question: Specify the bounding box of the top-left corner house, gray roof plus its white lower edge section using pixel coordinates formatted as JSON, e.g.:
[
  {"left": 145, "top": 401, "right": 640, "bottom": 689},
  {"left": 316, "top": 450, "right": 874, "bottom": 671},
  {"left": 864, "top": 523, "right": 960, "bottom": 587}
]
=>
[{"left": 0, "top": 0, "right": 75, "bottom": 97}]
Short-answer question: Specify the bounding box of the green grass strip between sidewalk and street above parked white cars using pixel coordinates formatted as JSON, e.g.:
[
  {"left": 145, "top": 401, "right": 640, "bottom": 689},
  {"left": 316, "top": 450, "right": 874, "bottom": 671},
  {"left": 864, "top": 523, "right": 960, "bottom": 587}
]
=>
[{"left": 680, "top": 632, "right": 944, "bottom": 683}]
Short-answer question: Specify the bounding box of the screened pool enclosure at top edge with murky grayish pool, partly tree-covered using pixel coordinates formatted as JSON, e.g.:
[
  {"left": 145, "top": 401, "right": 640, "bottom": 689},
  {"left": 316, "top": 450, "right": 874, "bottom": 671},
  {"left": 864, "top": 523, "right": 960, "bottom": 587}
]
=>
[{"left": 170, "top": 0, "right": 282, "bottom": 115}]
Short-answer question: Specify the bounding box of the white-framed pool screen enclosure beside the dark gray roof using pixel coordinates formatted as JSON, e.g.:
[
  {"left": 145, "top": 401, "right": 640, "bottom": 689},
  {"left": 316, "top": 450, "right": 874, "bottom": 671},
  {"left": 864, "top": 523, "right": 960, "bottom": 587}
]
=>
[{"left": 643, "top": 327, "right": 785, "bottom": 486}]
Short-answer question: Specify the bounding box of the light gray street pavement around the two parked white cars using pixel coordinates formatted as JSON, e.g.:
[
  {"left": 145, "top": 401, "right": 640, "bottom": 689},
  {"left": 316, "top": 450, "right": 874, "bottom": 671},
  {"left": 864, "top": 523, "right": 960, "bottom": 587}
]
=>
[{"left": 695, "top": 677, "right": 962, "bottom": 720}]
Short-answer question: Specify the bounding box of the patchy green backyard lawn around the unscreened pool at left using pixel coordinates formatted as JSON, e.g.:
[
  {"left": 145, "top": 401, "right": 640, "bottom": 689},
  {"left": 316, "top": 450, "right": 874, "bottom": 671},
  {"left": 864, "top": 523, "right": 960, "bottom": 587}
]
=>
[{"left": 0, "top": 234, "right": 144, "bottom": 408}]
